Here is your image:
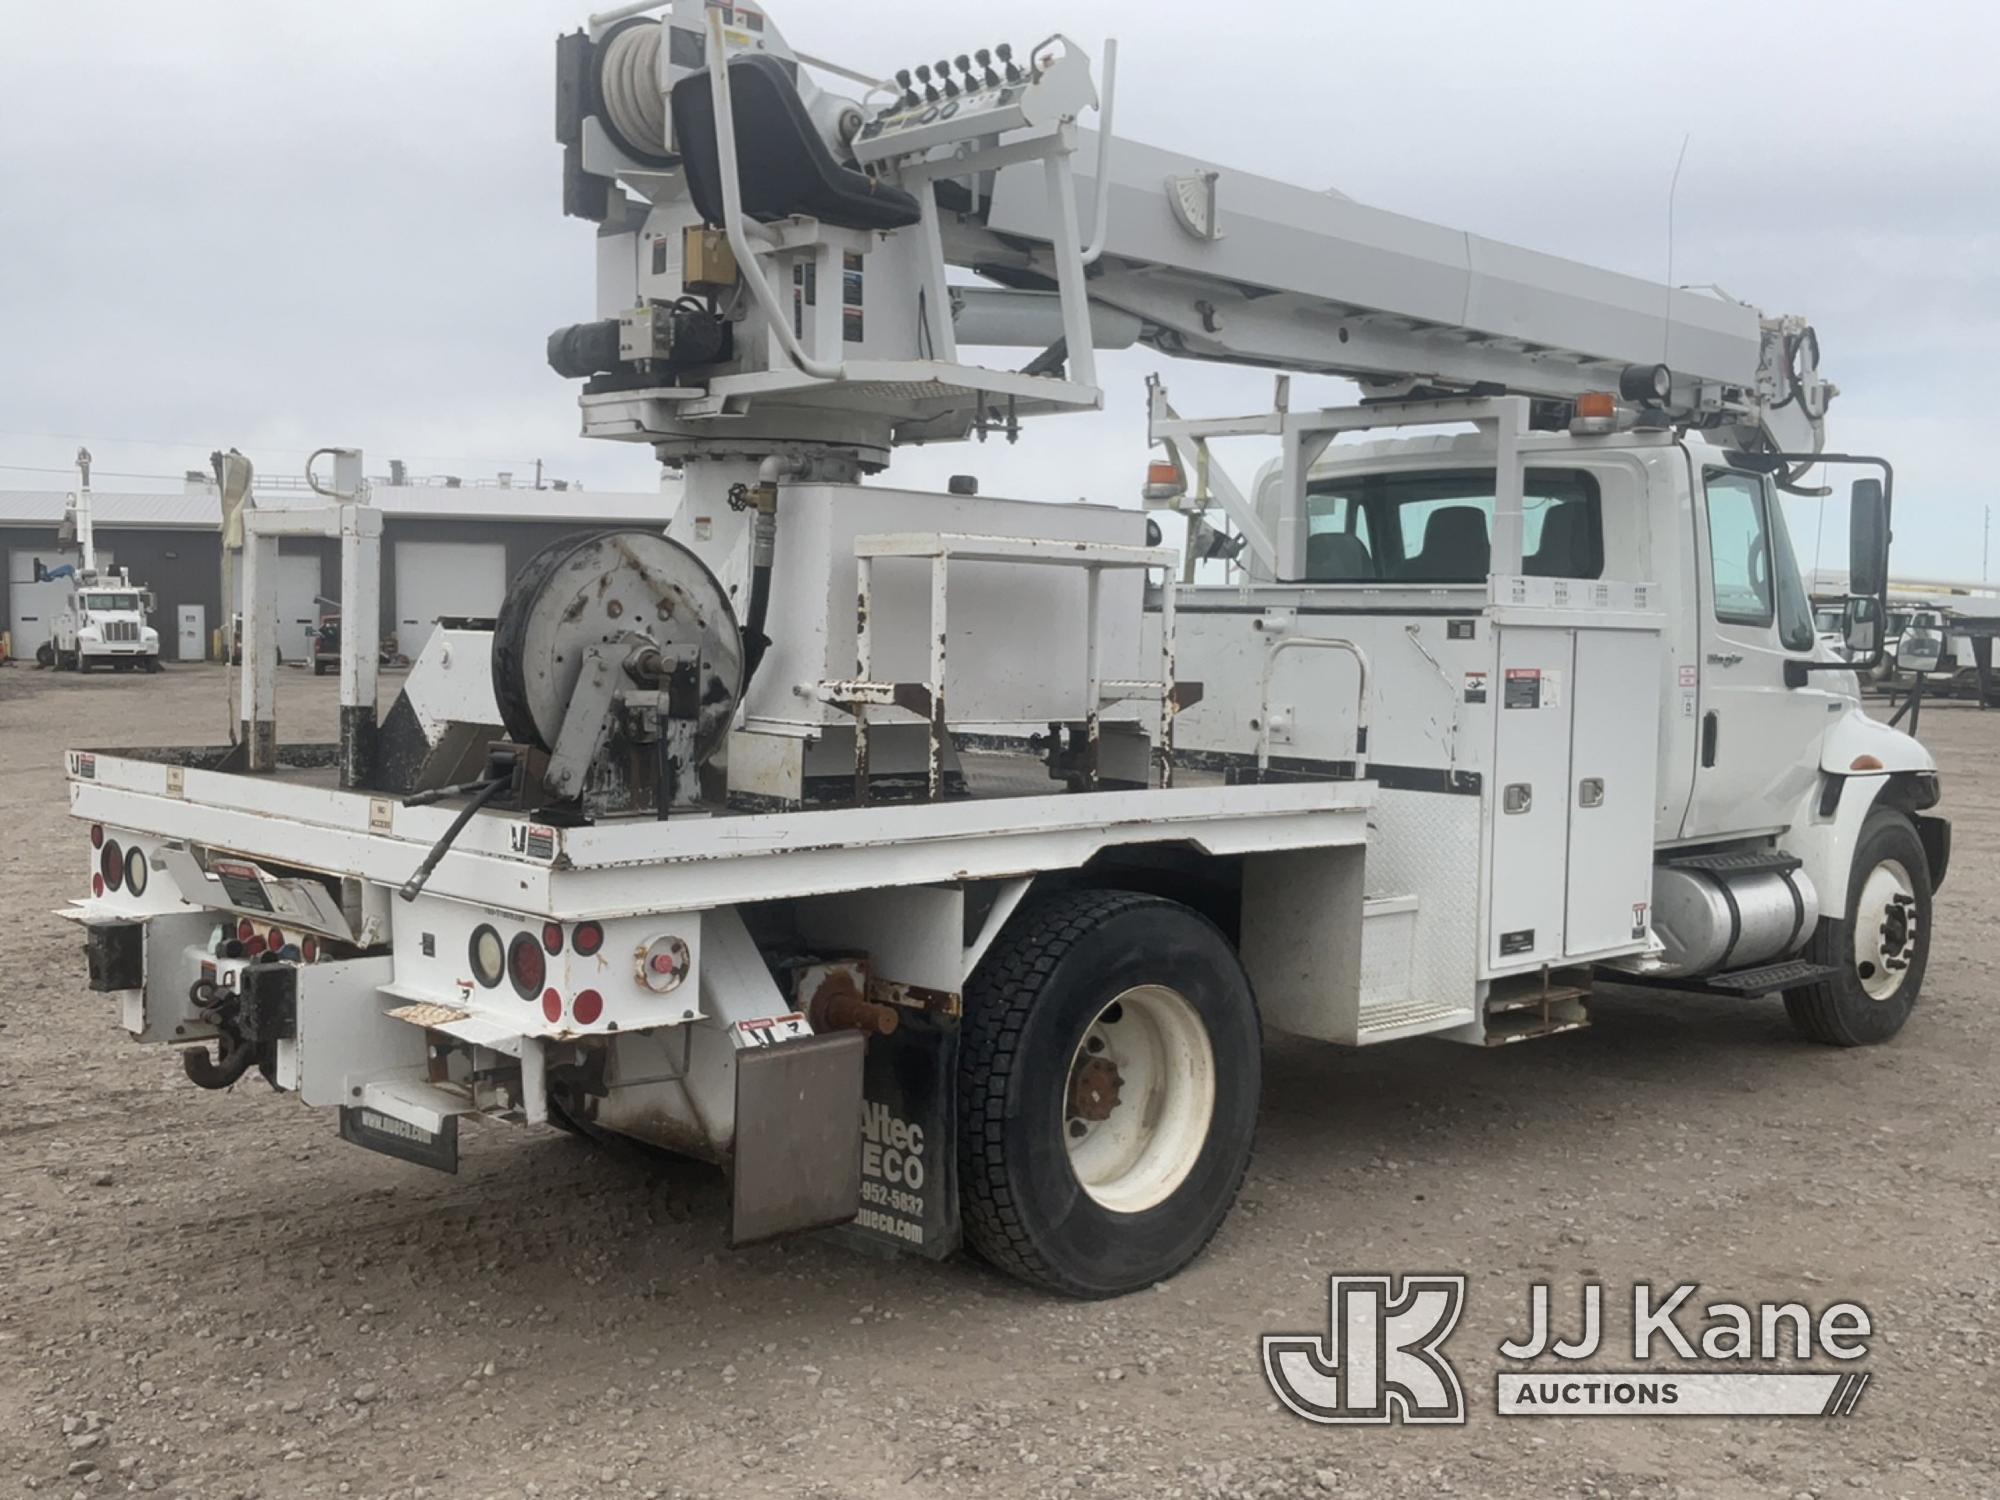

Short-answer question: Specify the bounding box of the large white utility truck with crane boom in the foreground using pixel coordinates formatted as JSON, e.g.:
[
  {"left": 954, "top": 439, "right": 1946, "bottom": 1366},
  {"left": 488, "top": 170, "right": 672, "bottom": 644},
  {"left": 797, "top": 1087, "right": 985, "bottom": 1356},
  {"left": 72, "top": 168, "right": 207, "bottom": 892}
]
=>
[{"left": 68, "top": 0, "right": 1950, "bottom": 1296}]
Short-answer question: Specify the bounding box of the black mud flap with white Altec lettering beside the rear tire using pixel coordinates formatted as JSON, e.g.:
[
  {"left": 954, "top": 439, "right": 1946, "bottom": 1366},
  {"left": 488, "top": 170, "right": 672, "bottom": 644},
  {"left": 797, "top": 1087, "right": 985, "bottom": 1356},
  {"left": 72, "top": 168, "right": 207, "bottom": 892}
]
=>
[{"left": 830, "top": 1010, "right": 962, "bottom": 1260}]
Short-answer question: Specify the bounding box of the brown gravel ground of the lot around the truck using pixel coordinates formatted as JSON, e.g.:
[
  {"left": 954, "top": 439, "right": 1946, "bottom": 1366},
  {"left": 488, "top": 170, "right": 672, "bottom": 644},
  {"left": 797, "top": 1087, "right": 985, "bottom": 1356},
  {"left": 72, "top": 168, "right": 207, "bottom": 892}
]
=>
[{"left": 0, "top": 668, "right": 2000, "bottom": 1500}]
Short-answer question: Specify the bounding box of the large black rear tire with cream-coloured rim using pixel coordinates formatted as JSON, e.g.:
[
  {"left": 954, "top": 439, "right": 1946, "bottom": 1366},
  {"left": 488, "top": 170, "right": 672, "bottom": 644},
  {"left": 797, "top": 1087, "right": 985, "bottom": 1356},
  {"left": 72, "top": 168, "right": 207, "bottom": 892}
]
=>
[{"left": 958, "top": 890, "right": 1262, "bottom": 1298}]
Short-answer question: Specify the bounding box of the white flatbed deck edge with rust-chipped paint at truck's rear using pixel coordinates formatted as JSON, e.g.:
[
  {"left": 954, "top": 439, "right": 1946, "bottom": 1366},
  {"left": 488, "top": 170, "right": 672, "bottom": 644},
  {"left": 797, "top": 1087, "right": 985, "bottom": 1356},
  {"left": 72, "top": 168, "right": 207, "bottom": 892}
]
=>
[{"left": 68, "top": 746, "right": 1376, "bottom": 920}]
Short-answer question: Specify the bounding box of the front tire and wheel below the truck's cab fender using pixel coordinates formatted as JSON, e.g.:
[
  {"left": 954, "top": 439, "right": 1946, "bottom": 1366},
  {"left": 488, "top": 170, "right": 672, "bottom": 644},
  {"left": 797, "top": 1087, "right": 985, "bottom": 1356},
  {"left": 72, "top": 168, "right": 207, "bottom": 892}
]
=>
[{"left": 1784, "top": 808, "right": 1932, "bottom": 1046}]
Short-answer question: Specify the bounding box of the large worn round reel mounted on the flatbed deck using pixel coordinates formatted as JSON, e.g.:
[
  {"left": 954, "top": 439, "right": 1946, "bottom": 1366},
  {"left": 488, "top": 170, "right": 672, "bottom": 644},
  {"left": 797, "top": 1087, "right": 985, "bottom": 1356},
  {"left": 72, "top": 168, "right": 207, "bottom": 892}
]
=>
[{"left": 492, "top": 528, "right": 744, "bottom": 818}]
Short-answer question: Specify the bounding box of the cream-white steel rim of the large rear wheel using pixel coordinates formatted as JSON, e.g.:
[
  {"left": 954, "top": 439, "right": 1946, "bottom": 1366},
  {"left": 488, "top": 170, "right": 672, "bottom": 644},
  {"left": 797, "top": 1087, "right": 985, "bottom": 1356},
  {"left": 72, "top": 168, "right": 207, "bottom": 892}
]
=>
[{"left": 1060, "top": 984, "right": 1216, "bottom": 1214}]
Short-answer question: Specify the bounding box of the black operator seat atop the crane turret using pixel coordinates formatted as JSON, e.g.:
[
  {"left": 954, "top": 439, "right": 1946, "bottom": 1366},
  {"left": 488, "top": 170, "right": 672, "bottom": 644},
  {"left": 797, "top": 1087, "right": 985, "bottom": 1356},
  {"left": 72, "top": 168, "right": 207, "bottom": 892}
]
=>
[{"left": 674, "top": 52, "right": 920, "bottom": 230}]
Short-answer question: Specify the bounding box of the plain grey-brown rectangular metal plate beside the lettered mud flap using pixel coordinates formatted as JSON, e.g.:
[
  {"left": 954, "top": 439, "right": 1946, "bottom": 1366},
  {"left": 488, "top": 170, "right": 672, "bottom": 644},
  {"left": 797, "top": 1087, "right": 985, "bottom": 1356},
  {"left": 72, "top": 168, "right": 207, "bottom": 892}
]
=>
[{"left": 730, "top": 1032, "right": 868, "bottom": 1246}]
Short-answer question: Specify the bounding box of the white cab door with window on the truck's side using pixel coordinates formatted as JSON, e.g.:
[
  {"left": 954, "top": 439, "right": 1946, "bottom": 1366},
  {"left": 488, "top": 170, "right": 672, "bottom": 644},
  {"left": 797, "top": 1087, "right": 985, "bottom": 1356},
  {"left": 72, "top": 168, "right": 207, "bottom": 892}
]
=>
[{"left": 1682, "top": 466, "right": 1838, "bottom": 838}]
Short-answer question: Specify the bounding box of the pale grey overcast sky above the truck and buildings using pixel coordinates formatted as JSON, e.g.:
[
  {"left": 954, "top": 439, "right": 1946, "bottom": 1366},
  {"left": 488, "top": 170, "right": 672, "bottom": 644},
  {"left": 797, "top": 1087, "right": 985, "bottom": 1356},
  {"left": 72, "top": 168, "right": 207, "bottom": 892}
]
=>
[{"left": 0, "top": 0, "right": 2000, "bottom": 578}]
